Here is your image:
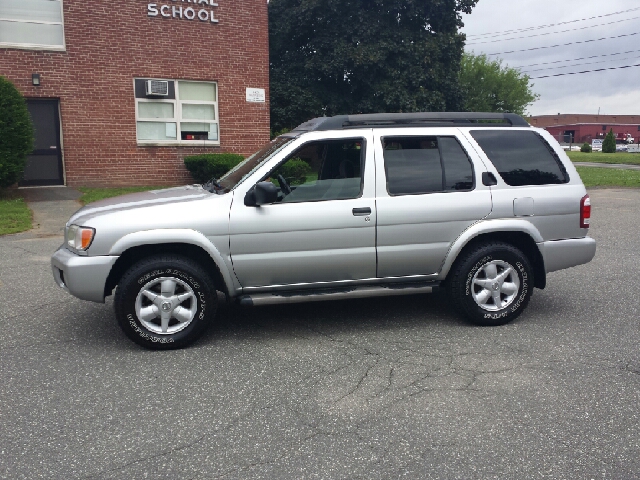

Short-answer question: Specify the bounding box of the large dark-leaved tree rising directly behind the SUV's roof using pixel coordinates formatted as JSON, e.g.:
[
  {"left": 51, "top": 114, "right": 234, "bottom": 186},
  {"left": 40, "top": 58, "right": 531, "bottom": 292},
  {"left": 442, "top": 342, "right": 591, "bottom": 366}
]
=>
[{"left": 269, "top": 0, "right": 477, "bottom": 131}]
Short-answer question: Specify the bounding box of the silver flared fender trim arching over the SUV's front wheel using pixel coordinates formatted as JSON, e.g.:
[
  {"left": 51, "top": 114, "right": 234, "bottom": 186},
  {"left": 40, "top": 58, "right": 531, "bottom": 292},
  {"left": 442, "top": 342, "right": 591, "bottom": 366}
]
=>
[{"left": 109, "top": 229, "right": 240, "bottom": 296}]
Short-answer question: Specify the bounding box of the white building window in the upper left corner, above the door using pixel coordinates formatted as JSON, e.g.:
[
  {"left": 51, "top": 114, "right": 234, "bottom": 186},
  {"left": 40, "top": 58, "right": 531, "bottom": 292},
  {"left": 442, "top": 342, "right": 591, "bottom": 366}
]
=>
[{"left": 0, "top": 0, "right": 65, "bottom": 50}]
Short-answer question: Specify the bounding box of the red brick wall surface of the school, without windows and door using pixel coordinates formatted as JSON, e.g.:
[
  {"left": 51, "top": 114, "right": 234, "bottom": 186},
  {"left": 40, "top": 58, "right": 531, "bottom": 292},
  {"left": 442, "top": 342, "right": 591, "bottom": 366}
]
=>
[{"left": 0, "top": 0, "right": 269, "bottom": 186}]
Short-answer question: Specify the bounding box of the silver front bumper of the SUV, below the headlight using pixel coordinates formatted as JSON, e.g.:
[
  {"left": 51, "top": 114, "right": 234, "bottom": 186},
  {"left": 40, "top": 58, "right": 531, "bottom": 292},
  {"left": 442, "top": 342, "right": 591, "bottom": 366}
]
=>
[{"left": 51, "top": 246, "right": 118, "bottom": 303}]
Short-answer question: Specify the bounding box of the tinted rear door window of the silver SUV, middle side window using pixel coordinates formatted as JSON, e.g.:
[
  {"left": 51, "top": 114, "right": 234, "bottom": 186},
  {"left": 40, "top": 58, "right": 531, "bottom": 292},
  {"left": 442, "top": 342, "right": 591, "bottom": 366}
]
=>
[{"left": 383, "top": 137, "right": 473, "bottom": 195}]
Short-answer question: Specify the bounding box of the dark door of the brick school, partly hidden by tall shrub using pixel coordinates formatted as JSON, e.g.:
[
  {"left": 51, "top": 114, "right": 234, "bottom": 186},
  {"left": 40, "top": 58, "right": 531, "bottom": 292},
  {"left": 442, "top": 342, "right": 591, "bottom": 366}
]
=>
[{"left": 20, "top": 98, "right": 64, "bottom": 186}]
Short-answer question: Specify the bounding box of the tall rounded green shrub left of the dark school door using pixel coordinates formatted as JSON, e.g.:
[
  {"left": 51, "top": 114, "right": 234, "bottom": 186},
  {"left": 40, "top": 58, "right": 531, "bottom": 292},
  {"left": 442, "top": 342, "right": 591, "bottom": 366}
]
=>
[{"left": 0, "top": 76, "right": 33, "bottom": 188}]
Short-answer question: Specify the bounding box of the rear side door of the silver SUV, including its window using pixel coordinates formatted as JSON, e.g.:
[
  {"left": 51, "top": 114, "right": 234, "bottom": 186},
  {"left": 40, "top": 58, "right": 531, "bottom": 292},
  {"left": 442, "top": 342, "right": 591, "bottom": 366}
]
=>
[{"left": 375, "top": 128, "right": 492, "bottom": 277}]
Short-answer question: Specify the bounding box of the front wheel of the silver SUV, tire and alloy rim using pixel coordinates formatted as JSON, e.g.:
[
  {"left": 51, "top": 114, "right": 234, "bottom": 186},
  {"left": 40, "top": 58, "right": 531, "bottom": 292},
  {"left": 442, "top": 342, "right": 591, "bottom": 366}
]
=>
[{"left": 114, "top": 254, "right": 218, "bottom": 350}]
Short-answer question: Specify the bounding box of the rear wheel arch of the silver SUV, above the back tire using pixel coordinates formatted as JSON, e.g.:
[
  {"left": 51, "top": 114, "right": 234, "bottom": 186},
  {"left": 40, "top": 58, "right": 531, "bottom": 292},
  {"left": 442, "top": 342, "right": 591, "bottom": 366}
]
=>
[{"left": 441, "top": 222, "right": 547, "bottom": 289}]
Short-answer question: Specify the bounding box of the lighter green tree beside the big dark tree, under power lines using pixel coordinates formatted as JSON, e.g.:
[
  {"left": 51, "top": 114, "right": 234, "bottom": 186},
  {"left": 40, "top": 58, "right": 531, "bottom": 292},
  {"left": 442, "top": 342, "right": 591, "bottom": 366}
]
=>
[{"left": 460, "top": 53, "right": 539, "bottom": 115}]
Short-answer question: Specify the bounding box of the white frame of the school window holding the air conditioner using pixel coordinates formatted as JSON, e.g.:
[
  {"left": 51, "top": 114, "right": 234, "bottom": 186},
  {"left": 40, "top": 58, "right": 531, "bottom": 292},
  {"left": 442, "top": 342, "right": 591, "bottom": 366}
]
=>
[{"left": 133, "top": 78, "right": 220, "bottom": 147}]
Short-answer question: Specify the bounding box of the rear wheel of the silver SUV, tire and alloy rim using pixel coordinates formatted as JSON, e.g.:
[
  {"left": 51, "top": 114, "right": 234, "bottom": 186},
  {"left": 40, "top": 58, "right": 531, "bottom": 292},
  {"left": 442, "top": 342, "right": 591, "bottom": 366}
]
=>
[{"left": 447, "top": 242, "right": 534, "bottom": 327}]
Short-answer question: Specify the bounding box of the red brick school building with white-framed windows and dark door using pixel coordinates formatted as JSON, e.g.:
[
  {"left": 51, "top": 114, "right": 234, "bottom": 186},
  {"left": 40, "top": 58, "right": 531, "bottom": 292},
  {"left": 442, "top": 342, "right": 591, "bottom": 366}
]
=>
[{"left": 0, "top": 0, "right": 269, "bottom": 186}]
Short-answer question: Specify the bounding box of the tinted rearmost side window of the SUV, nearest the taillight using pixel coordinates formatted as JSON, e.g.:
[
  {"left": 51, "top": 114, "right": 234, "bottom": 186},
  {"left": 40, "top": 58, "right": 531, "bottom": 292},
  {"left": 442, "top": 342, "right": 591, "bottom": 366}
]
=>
[{"left": 471, "top": 130, "right": 569, "bottom": 186}]
